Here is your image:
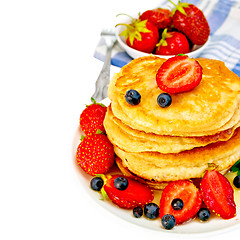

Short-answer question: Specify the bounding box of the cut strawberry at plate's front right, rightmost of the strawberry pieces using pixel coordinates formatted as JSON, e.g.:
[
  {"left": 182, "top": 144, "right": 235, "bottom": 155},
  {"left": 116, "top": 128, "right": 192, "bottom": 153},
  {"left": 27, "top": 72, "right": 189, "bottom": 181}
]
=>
[{"left": 200, "top": 170, "right": 236, "bottom": 219}]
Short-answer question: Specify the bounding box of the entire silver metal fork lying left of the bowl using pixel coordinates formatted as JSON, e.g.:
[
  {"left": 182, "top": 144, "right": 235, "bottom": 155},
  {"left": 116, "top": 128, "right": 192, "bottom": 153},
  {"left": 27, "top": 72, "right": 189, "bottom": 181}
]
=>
[{"left": 92, "top": 29, "right": 116, "bottom": 102}]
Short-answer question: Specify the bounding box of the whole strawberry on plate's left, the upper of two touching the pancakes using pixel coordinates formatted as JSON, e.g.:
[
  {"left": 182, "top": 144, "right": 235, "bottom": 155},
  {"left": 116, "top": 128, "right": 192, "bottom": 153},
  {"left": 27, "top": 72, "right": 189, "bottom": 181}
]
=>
[{"left": 80, "top": 98, "right": 107, "bottom": 135}]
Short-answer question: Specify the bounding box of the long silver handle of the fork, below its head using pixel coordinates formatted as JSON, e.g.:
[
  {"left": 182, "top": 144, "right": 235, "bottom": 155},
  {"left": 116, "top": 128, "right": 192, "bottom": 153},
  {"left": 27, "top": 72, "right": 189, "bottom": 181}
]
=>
[{"left": 92, "top": 44, "right": 113, "bottom": 102}]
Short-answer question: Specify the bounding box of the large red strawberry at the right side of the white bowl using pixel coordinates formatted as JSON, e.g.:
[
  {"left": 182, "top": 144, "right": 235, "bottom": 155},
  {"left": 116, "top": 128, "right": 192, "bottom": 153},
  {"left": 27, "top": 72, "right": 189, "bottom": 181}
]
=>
[{"left": 169, "top": 0, "right": 210, "bottom": 45}]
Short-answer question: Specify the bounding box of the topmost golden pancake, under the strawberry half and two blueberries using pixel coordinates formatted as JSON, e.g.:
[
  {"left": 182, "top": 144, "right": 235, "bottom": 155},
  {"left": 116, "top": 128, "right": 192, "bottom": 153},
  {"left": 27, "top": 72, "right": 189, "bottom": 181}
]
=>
[{"left": 108, "top": 55, "right": 240, "bottom": 136}]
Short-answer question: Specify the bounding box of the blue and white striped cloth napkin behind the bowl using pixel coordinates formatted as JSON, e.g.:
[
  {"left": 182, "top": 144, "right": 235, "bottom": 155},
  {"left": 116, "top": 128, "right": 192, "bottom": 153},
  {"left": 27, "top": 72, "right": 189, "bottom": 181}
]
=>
[{"left": 94, "top": 0, "right": 240, "bottom": 76}]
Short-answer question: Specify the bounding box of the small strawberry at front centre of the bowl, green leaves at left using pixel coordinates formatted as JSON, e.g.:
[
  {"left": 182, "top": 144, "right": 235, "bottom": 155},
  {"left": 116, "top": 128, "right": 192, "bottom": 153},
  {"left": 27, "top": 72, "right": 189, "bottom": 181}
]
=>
[{"left": 155, "top": 28, "right": 190, "bottom": 55}]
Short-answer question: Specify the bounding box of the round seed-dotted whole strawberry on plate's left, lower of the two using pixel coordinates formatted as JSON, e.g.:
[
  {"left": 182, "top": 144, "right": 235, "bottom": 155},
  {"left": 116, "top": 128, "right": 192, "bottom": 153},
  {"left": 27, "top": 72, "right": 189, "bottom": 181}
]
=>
[{"left": 76, "top": 134, "right": 115, "bottom": 176}]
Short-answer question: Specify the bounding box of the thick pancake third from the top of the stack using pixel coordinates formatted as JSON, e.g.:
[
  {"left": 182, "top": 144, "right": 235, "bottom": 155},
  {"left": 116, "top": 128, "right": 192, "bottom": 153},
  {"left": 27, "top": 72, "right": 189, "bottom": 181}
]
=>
[{"left": 114, "top": 128, "right": 240, "bottom": 182}]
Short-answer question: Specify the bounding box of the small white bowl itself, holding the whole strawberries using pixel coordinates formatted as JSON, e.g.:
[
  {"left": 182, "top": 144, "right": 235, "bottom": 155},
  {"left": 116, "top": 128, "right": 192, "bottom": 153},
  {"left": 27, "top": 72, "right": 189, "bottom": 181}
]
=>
[{"left": 115, "top": 25, "right": 210, "bottom": 59}]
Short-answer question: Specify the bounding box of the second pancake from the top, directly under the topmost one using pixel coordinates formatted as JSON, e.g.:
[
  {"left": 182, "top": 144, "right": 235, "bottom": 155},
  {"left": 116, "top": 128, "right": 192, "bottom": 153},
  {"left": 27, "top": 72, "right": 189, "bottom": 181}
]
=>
[{"left": 104, "top": 106, "right": 240, "bottom": 153}]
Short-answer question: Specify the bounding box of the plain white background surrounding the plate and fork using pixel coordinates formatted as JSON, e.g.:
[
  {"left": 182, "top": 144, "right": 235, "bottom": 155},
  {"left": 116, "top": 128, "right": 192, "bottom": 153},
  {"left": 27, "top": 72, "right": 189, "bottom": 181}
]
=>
[{"left": 0, "top": 0, "right": 240, "bottom": 240}]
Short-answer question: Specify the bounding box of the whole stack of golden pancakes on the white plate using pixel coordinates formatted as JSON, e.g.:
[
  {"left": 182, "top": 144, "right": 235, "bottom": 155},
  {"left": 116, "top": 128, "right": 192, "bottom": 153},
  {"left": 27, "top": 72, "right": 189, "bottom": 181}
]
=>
[{"left": 104, "top": 55, "right": 240, "bottom": 189}]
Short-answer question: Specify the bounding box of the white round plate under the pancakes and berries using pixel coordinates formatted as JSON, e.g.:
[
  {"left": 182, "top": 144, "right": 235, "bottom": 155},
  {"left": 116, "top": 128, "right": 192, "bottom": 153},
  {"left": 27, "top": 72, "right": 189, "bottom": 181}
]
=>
[{"left": 73, "top": 99, "right": 240, "bottom": 237}]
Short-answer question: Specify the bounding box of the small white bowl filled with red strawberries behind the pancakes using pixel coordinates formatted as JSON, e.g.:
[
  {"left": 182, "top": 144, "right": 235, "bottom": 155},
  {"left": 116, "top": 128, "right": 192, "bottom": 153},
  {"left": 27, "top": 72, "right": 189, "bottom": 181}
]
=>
[{"left": 116, "top": 0, "right": 210, "bottom": 58}]
